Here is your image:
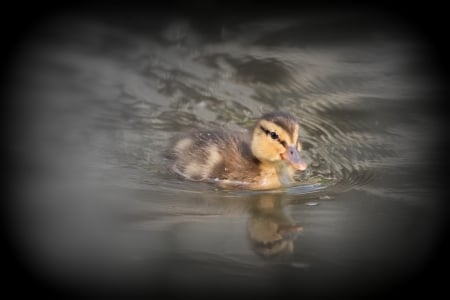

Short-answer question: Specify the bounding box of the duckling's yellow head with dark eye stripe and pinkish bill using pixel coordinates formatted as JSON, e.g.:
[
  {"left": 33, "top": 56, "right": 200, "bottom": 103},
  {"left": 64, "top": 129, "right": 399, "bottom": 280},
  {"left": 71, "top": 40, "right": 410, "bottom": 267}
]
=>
[{"left": 251, "top": 112, "right": 307, "bottom": 170}]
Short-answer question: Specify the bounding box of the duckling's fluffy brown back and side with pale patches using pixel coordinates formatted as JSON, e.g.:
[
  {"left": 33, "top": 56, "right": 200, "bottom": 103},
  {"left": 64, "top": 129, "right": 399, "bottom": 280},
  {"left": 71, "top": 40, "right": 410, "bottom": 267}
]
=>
[{"left": 169, "top": 130, "right": 259, "bottom": 185}]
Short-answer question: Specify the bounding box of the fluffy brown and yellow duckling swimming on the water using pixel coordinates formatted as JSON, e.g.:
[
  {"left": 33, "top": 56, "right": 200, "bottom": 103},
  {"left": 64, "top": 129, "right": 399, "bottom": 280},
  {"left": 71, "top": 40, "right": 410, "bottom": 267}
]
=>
[{"left": 169, "top": 112, "right": 307, "bottom": 190}]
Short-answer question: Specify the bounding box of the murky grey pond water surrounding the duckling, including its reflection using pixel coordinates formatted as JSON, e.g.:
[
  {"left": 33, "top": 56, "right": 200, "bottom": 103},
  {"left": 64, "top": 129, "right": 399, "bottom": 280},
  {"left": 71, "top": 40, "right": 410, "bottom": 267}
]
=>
[{"left": 9, "top": 10, "right": 443, "bottom": 295}]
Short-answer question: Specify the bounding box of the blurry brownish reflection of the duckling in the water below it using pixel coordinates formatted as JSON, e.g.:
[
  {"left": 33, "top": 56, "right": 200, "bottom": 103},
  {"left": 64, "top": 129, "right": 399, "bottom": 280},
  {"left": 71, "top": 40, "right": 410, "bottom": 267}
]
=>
[{"left": 247, "top": 194, "right": 303, "bottom": 259}]
